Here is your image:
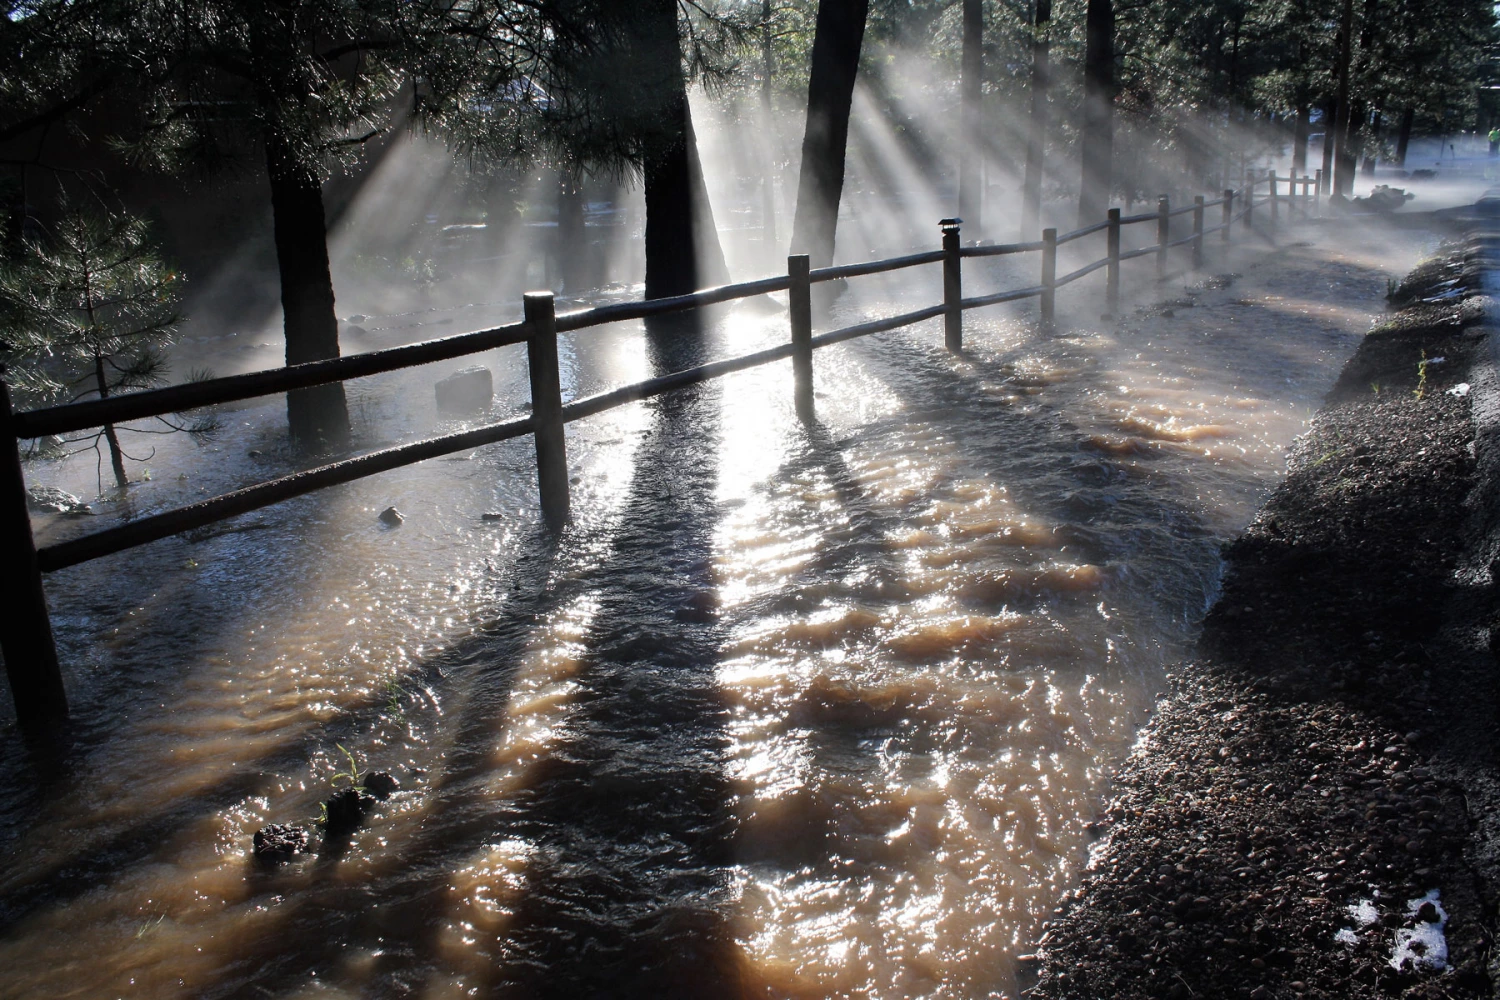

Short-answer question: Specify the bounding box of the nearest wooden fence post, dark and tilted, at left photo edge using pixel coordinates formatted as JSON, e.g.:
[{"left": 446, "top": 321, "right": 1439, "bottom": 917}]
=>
[{"left": 0, "top": 367, "right": 68, "bottom": 729}]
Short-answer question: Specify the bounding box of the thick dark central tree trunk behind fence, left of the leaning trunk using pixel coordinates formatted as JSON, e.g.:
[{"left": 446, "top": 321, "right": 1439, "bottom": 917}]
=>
[{"left": 642, "top": 0, "right": 729, "bottom": 298}]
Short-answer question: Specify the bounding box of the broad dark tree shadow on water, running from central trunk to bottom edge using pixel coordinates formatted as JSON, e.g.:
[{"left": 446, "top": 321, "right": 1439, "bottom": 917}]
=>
[{"left": 477, "top": 330, "right": 738, "bottom": 997}]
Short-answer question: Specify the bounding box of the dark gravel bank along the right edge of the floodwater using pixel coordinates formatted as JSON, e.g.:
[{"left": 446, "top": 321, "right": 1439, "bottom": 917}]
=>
[{"left": 1025, "top": 235, "right": 1500, "bottom": 1000}]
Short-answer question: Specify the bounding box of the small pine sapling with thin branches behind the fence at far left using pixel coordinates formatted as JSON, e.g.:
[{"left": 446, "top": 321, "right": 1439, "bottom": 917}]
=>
[{"left": 0, "top": 211, "right": 218, "bottom": 490}]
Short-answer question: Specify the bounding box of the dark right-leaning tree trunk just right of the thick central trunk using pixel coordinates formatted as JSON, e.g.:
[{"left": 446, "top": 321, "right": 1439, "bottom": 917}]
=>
[{"left": 792, "top": 0, "right": 870, "bottom": 267}]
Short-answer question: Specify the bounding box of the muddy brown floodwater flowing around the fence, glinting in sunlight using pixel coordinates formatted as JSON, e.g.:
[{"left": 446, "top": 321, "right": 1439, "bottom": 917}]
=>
[{"left": 0, "top": 220, "right": 1431, "bottom": 999}]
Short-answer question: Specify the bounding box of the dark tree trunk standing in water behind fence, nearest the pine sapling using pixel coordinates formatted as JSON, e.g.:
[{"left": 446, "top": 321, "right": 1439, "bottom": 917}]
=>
[{"left": 266, "top": 129, "right": 350, "bottom": 448}]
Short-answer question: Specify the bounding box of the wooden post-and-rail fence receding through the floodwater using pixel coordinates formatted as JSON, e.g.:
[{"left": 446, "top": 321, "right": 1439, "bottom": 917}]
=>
[{"left": 0, "top": 171, "right": 1322, "bottom": 727}]
